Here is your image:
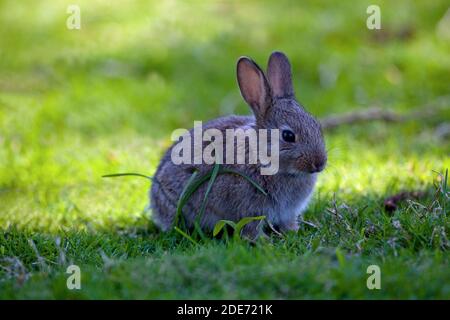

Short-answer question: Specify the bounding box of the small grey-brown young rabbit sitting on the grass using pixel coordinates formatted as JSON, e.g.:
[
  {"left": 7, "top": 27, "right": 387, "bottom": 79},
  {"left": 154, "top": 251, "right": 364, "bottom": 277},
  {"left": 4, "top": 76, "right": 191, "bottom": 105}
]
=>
[{"left": 150, "top": 51, "right": 327, "bottom": 239}]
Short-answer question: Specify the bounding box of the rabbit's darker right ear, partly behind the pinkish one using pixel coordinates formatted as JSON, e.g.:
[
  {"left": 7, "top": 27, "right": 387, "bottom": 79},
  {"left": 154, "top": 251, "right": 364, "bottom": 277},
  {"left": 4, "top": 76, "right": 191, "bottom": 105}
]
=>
[{"left": 267, "top": 51, "right": 294, "bottom": 98}]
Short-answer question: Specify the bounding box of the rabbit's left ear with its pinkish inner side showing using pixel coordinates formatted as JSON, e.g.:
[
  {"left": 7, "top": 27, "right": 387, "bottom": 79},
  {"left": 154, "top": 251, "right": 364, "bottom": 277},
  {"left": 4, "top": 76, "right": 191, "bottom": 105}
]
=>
[{"left": 237, "top": 57, "right": 271, "bottom": 119}]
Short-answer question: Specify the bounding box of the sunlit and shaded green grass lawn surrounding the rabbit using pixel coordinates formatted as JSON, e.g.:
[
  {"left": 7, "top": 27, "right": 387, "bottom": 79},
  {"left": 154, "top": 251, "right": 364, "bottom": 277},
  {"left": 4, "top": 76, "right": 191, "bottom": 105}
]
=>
[{"left": 0, "top": 0, "right": 450, "bottom": 299}]
